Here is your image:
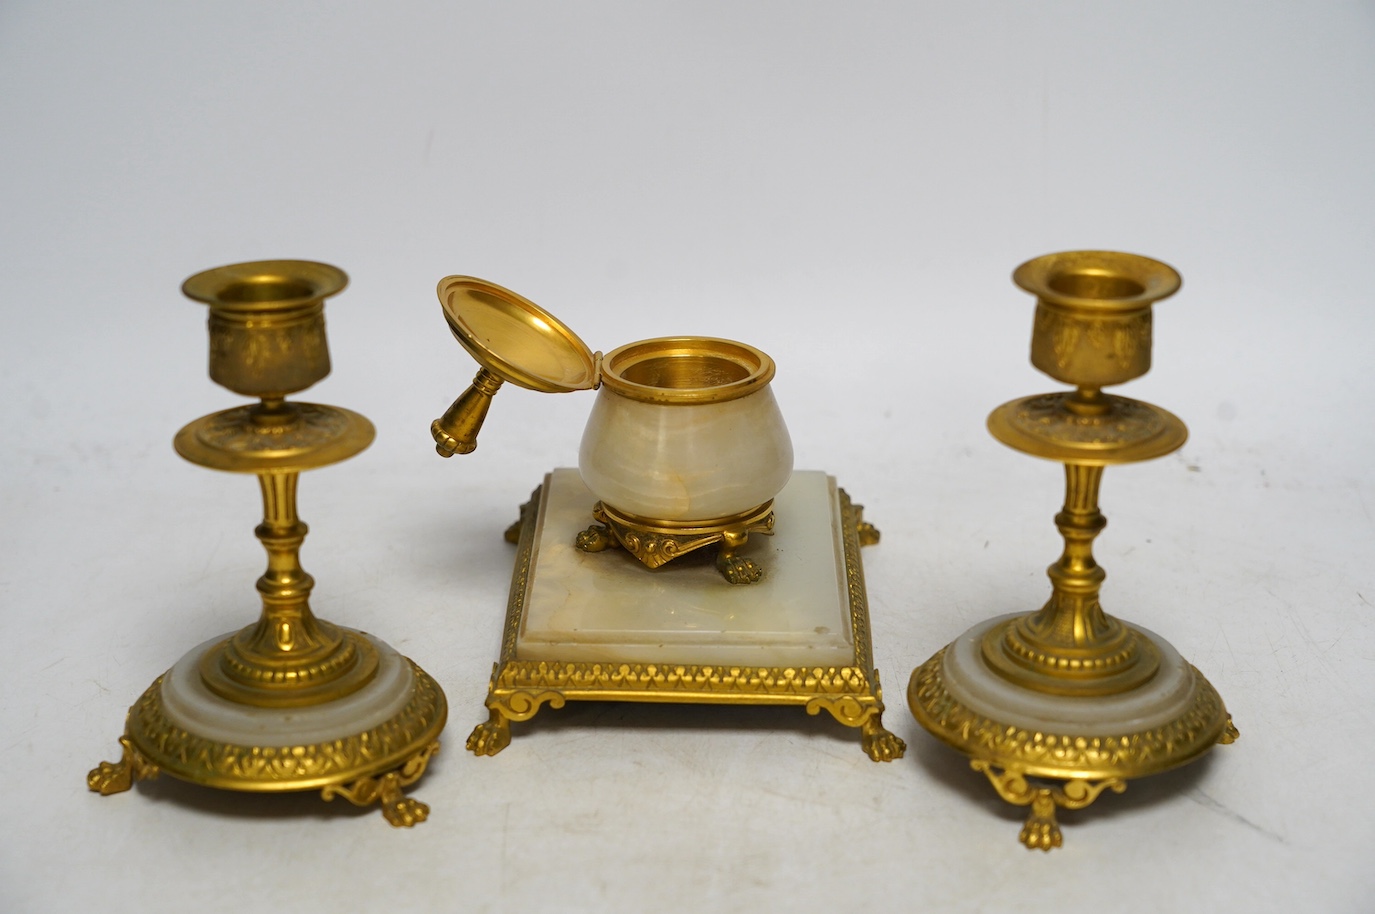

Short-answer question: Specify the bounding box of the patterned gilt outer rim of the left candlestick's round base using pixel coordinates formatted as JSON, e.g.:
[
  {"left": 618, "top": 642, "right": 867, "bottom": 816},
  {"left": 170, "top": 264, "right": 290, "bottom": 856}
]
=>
[{"left": 125, "top": 658, "right": 448, "bottom": 793}]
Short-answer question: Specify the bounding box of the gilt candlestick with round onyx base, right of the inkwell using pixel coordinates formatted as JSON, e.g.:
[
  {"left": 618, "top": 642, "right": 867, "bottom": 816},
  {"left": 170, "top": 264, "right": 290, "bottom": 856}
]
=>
[{"left": 908, "top": 252, "right": 1238, "bottom": 851}]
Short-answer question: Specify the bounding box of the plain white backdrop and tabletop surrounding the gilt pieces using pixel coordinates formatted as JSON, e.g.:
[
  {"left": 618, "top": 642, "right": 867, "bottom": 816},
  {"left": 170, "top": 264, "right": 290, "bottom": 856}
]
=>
[{"left": 0, "top": 0, "right": 1375, "bottom": 911}]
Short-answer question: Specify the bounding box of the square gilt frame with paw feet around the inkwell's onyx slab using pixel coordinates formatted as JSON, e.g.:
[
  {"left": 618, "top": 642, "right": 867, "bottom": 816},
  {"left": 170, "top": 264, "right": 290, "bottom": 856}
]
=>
[{"left": 468, "top": 489, "right": 906, "bottom": 761}]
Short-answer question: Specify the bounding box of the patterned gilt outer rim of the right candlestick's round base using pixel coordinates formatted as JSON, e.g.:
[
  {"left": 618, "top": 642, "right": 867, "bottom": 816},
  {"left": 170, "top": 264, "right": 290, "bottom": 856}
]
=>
[{"left": 908, "top": 647, "right": 1229, "bottom": 779}]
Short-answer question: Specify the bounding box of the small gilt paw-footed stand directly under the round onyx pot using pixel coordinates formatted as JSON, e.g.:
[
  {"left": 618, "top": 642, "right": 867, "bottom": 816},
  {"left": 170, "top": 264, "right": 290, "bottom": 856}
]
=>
[{"left": 576, "top": 500, "right": 774, "bottom": 584}]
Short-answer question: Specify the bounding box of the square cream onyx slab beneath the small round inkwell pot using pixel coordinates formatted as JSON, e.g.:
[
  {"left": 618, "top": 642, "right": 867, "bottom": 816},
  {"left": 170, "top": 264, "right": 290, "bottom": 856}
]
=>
[{"left": 516, "top": 470, "right": 854, "bottom": 667}]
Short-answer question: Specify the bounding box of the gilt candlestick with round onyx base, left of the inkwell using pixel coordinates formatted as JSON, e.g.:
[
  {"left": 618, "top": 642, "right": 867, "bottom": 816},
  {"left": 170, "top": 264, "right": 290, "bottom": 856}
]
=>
[{"left": 87, "top": 261, "right": 447, "bottom": 826}]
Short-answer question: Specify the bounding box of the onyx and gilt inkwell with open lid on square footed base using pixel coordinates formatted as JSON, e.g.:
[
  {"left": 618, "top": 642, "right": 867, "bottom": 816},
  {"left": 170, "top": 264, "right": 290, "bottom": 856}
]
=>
[{"left": 430, "top": 276, "right": 903, "bottom": 761}]
